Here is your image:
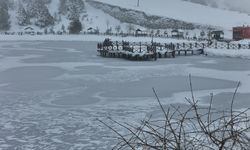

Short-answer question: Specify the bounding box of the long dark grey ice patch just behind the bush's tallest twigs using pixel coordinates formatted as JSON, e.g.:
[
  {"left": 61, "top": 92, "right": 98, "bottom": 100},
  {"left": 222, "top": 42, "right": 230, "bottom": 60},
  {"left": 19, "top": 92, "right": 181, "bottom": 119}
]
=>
[{"left": 99, "top": 76, "right": 236, "bottom": 99}]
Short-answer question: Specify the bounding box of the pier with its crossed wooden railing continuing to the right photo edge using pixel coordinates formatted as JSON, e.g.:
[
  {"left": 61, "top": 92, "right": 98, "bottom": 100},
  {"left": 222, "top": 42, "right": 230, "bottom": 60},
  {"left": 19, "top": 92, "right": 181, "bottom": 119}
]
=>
[{"left": 97, "top": 40, "right": 250, "bottom": 60}]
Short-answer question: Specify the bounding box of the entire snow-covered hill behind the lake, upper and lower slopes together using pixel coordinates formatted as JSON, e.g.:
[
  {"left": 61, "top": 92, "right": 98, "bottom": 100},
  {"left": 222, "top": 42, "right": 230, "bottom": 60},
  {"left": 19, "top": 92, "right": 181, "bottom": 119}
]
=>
[{"left": 4, "top": 0, "right": 250, "bottom": 32}]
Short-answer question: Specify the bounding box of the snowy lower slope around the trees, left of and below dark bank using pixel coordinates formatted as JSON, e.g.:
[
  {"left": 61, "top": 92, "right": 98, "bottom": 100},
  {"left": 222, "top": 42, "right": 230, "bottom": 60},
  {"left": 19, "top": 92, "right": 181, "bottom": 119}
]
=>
[{"left": 9, "top": 0, "right": 141, "bottom": 32}]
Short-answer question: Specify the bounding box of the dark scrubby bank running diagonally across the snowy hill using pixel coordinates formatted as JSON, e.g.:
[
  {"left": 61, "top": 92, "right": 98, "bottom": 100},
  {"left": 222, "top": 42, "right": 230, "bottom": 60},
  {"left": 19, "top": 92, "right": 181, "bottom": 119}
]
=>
[{"left": 86, "top": 0, "right": 212, "bottom": 30}]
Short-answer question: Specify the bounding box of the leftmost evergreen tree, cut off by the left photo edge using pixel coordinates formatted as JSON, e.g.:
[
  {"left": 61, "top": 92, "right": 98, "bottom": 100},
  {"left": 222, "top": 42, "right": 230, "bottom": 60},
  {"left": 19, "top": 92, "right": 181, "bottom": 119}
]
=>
[{"left": 0, "top": 0, "right": 10, "bottom": 30}]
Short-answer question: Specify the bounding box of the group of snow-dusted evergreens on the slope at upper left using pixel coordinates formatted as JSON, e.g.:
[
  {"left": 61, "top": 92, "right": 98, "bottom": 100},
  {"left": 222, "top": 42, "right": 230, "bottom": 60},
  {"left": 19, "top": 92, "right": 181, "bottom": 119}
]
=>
[{"left": 0, "top": 0, "right": 85, "bottom": 34}]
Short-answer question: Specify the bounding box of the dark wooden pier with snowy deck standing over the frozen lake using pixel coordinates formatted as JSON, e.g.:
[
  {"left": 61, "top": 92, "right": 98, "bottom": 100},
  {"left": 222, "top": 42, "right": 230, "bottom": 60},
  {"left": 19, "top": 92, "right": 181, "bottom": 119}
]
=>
[{"left": 97, "top": 40, "right": 205, "bottom": 61}]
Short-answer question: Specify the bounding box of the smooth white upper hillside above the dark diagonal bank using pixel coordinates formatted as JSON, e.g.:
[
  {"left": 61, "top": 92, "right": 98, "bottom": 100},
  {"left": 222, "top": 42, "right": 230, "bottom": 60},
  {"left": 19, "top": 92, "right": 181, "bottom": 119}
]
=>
[{"left": 96, "top": 0, "right": 250, "bottom": 29}]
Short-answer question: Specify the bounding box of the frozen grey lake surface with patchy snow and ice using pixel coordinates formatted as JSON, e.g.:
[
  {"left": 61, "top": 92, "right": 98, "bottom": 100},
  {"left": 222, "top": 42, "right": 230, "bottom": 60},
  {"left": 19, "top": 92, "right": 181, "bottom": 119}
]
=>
[{"left": 0, "top": 41, "right": 250, "bottom": 150}]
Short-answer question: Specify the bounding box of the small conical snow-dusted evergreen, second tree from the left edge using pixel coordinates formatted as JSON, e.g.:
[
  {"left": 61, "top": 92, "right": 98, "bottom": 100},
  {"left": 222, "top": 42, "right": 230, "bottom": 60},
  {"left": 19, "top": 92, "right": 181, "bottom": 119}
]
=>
[{"left": 17, "top": 3, "right": 30, "bottom": 26}]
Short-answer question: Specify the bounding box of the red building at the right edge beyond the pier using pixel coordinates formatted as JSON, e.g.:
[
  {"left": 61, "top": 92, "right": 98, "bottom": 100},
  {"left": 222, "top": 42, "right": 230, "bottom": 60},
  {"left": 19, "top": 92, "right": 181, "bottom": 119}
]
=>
[{"left": 233, "top": 26, "right": 250, "bottom": 40}]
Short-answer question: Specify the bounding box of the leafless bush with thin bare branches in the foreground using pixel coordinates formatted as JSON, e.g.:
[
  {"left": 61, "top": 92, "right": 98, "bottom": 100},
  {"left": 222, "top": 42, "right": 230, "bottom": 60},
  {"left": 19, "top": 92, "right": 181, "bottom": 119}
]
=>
[{"left": 99, "top": 76, "right": 250, "bottom": 150}]
